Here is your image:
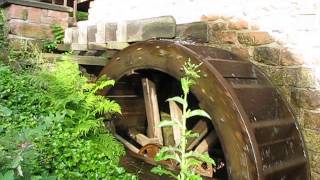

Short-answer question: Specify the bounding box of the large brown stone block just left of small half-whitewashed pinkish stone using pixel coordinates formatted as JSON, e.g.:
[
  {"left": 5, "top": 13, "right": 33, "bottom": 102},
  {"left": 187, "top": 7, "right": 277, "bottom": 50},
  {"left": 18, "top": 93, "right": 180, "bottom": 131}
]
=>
[{"left": 253, "top": 46, "right": 280, "bottom": 65}]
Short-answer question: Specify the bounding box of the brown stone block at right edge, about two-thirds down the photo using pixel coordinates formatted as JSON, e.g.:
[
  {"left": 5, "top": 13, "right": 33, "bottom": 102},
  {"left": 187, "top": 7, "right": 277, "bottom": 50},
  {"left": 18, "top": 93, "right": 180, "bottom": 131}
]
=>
[{"left": 303, "top": 110, "right": 320, "bottom": 131}]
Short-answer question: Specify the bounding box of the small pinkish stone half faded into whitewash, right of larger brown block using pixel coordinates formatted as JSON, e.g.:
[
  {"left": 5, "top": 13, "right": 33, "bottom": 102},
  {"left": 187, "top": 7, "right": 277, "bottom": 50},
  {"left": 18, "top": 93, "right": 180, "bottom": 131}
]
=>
[{"left": 280, "top": 49, "right": 304, "bottom": 66}]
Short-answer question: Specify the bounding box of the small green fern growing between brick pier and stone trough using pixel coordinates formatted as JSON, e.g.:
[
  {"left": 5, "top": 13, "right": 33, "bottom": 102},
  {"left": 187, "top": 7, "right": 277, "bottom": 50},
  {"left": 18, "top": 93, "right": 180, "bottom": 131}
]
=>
[{"left": 43, "top": 24, "right": 64, "bottom": 52}]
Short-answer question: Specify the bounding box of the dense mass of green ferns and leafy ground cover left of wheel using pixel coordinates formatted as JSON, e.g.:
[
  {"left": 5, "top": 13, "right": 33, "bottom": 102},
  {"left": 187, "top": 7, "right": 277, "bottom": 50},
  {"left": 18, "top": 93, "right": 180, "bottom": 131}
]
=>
[{"left": 0, "top": 61, "right": 136, "bottom": 179}]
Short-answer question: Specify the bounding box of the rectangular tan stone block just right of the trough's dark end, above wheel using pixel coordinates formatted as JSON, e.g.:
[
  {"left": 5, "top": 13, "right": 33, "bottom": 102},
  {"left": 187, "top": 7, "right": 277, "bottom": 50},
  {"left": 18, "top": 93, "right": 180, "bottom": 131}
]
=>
[{"left": 209, "top": 31, "right": 237, "bottom": 44}]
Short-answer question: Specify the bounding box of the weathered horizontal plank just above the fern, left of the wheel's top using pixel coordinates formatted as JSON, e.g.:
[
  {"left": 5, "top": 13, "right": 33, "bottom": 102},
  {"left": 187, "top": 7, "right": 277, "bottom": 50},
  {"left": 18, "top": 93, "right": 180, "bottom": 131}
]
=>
[{"left": 43, "top": 53, "right": 108, "bottom": 66}]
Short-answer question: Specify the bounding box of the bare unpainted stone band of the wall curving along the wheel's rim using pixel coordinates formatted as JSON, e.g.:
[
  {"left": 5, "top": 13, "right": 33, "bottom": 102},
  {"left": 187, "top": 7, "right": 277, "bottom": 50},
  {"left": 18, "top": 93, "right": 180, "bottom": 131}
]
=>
[{"left": 203, "top": 16, "right": 320, "bottom": 180}]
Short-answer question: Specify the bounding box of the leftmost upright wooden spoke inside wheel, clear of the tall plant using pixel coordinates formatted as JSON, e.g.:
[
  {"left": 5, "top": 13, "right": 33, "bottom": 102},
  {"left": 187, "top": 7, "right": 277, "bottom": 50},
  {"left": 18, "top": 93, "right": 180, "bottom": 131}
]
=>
[{"left": 141, "top": 78, "right": 163, "bottom": 145}]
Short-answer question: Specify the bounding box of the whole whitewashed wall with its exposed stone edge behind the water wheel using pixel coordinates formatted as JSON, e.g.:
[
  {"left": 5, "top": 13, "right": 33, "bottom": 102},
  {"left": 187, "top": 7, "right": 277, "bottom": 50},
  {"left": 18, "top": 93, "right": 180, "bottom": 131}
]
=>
[{"left": 85, "top": 0, "right": 320, "bottom": 179}]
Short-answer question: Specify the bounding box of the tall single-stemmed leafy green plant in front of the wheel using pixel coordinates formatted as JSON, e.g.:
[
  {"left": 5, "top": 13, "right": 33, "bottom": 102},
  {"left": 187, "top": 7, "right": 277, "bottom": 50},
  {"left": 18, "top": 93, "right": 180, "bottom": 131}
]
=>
[{"left": 151, "top": 59, "right": 215, "bottom": 180}]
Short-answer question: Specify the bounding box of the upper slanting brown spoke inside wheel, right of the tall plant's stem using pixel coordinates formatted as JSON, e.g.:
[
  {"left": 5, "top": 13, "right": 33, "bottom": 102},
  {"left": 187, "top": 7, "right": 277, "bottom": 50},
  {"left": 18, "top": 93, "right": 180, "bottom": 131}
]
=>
[{"left": 187, "top": 120, "right": 208, "bottom": 151}]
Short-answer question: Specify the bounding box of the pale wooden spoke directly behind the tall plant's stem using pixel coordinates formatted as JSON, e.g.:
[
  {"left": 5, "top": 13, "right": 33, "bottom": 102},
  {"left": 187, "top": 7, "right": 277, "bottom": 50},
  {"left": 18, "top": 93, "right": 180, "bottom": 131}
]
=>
[{"left": 169, "top": 101, "right": 182, "bottom": 146}]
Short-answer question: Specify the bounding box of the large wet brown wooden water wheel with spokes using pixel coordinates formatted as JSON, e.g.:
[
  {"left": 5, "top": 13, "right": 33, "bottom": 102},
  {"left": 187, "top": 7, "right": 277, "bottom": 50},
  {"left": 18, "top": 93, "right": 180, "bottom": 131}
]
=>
[{"left": 100, "top": 40, "right": 310, "bottom": 180}]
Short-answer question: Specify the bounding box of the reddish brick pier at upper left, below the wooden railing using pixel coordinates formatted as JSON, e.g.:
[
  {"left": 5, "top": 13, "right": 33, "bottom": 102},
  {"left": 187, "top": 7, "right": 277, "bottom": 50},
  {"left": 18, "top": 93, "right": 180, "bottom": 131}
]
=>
[{"left": 5, "top": 4, "right": 69, "bottom": 39}]
